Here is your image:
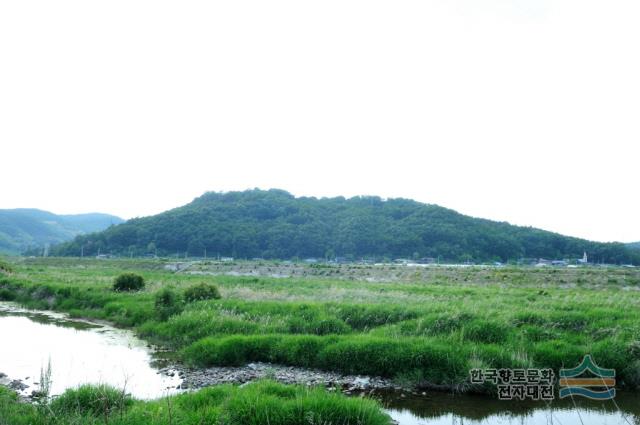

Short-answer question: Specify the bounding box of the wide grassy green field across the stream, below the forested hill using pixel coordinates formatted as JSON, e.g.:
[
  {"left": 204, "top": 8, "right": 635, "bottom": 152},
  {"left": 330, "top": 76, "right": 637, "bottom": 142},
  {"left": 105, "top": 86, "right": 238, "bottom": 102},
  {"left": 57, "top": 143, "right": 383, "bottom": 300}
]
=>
[{"left": 0, "top": 255, "right": 640, "bottom": 423}]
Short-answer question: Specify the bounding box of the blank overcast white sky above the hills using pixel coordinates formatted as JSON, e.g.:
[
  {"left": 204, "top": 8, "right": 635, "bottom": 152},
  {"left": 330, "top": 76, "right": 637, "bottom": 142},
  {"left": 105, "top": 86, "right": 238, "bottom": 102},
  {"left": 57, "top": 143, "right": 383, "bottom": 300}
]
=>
[{"left": 0, "top": 0, "right": 640, "bottom": 241}]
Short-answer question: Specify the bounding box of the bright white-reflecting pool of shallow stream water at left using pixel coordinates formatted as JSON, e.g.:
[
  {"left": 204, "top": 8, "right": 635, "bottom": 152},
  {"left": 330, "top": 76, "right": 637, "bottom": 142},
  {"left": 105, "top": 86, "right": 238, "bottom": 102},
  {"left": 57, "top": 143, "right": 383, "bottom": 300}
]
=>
[{"left": 0, "top": 303, "right": 180, "bottom": 399}]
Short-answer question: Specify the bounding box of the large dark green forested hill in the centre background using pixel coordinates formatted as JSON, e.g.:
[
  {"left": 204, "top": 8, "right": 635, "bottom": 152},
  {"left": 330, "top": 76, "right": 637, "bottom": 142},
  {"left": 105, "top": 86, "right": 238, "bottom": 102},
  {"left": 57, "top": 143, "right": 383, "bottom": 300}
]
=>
[{"left": 53, "top": 189, "right": 640, "bottom": 264}]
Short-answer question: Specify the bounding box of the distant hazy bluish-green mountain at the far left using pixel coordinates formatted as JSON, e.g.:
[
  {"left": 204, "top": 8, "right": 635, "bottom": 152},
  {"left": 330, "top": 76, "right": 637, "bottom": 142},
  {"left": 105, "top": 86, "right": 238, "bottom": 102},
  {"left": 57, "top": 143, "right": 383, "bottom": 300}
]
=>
[{"left": 0, "top": 208, "right": 123, "bottom": 254}]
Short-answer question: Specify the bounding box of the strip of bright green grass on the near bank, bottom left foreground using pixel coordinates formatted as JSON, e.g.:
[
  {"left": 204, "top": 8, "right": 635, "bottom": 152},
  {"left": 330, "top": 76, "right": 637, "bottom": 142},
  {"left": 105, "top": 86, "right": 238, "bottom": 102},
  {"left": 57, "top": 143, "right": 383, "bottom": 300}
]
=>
[{"left": 0, "top": 381, "right": 389, "bottom": 425}]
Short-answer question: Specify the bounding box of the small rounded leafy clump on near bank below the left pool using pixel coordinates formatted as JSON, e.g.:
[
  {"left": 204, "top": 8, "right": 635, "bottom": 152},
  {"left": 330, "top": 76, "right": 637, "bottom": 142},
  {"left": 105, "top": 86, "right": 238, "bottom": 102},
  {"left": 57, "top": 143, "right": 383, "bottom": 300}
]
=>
[{"left": 51, "top": 385, "right": 133, "bottom": 417}]
